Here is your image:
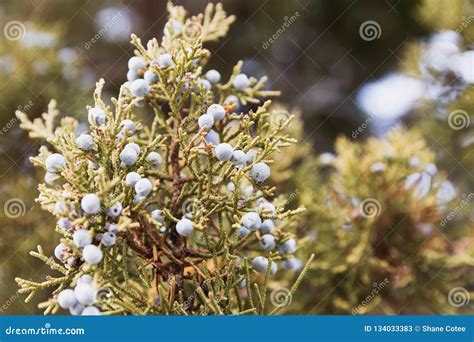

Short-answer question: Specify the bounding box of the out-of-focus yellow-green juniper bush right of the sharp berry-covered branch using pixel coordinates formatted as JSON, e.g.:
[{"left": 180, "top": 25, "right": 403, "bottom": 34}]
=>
[{"left": 275, "top": 125, "right": 474, "bottom": 314}]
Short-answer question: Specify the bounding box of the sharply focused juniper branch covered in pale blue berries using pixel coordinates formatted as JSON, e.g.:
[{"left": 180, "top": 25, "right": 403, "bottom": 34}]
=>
[{"left": 16, "top": 4, "right": 312, "bottom": 315}]
